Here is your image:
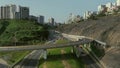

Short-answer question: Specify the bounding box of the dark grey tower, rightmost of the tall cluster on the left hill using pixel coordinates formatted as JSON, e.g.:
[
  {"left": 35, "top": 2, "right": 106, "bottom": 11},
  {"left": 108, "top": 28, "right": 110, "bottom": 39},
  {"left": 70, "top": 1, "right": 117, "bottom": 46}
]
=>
[{"left": 19, "top": 6, "right": 29, "bottom": 19}]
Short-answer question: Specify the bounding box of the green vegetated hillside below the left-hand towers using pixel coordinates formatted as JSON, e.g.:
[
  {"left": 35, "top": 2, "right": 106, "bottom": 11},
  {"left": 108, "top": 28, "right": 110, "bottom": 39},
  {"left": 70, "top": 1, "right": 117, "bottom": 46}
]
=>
[{"left": 0, "top": 20, "right": 49, "bottom": 46}]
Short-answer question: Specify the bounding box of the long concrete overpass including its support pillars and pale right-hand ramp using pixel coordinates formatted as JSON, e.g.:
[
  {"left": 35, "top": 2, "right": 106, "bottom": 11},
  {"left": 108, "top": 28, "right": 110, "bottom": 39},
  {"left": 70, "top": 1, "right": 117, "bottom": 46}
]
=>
[{"left": 0, "top": 31, "right": 106, "bottom": 68}]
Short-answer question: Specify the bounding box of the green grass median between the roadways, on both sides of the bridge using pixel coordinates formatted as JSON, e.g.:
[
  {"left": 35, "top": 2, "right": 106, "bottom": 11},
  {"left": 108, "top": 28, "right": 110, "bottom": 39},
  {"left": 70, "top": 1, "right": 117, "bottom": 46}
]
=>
[{"left": 39, "top": 40, "right": 84, "bottom": 68}]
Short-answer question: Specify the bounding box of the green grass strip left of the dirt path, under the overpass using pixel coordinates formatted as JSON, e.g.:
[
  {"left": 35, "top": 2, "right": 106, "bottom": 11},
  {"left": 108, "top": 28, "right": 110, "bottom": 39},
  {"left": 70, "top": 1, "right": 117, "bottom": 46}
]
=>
[{"left": 39, "top": 48, "right": 64, "bottom": 68}]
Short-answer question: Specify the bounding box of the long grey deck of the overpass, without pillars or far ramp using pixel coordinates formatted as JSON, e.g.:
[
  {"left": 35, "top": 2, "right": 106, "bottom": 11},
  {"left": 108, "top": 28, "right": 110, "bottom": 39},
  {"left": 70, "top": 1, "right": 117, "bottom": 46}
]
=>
[{"left": 0, "top": 39, "right": 93, "bottom": 51}]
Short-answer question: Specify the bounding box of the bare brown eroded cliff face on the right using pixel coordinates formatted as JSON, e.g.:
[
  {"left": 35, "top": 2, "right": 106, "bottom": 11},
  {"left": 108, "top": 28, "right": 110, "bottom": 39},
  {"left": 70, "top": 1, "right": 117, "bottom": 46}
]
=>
[{"left": 57, "top": 15, "right": 120, "bottom": 46}]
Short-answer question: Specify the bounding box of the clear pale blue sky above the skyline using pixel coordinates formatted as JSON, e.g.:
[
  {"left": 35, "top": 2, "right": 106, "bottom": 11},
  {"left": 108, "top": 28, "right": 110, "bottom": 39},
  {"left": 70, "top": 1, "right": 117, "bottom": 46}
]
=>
[{"left": 0, "top": 0, "right": 116, "bottom": 22}]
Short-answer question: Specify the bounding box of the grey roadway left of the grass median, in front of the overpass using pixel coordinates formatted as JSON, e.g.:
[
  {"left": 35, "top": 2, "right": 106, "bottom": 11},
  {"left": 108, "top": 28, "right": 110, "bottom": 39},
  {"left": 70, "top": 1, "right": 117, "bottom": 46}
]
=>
[{"left": 14, "top": 50, "right": 42, "bottom": 68}]
